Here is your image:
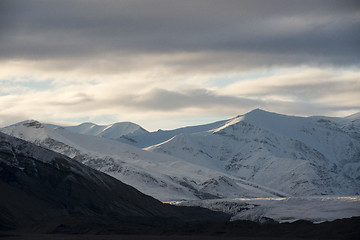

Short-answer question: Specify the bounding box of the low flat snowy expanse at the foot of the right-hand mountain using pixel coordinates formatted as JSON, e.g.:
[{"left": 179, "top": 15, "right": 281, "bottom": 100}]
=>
[{"left": 172, "top": 196, "right": 360, "bottom": 223}]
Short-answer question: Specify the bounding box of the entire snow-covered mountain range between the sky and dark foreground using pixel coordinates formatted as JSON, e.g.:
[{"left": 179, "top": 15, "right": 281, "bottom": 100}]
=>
[{"left": 1, "top": 109, "right": 360, "bottom": 201}]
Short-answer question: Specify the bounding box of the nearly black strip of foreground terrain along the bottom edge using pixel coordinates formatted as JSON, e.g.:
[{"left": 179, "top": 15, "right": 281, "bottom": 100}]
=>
[{"left": 0, "top": 217, "right": 360, "bottom": 240}]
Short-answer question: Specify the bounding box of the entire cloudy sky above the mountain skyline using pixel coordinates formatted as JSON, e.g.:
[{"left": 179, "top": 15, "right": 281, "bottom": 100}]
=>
[{"left": 0, "top": 0, "right": 360, "bottom": 130}]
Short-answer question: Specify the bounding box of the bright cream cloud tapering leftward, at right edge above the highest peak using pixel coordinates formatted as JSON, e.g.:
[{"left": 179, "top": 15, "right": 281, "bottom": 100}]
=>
[{"left": 221, "top": 68, "right": 360, "bottom": 107}]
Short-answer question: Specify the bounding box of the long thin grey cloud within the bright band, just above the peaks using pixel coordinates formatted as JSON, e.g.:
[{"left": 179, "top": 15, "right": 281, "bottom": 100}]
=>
[{"left": 110, "top": 89, "right": 360, "bottom": 116}]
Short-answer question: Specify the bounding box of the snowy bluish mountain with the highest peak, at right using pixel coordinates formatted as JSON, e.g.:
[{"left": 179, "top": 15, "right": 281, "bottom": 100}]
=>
[{"left": 147, "top": 109, "right": 360, "bottom": 196}]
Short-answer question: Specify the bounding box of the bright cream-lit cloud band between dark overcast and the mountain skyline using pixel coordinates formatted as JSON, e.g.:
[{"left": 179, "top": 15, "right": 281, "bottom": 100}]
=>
[{"left": 0, "top": 65, "right": 360, "bottom": 130}]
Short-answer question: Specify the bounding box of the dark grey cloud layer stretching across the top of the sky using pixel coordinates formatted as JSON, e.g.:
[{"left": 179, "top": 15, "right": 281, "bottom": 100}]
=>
[{"left": 0, "top": 0, "right": 360, "bottom": 70}]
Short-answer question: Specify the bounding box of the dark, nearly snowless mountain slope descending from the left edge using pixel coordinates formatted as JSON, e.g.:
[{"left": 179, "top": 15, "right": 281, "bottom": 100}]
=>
[{"left": 0, "top": 133, "right": 226, "bottom": 230}]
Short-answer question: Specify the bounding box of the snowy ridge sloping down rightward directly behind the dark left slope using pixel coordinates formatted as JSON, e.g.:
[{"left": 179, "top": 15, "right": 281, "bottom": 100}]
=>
[{"left": 1, "top": 120, "right": 284, "bottom": 201}]
